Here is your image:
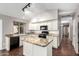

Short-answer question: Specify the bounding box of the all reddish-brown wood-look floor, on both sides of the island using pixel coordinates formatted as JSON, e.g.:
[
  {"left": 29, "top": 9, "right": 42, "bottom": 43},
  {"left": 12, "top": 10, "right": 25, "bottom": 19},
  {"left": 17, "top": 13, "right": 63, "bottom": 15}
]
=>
[{"left": 0, "top": 38, "right": 76, "bottom": 56}]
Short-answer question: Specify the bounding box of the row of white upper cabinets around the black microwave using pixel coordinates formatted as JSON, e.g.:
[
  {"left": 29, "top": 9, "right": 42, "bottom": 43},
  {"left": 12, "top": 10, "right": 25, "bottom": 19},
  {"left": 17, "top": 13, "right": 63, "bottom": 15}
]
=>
[{"left": 29, "top": 20, "right": 58, "bottom": 30}]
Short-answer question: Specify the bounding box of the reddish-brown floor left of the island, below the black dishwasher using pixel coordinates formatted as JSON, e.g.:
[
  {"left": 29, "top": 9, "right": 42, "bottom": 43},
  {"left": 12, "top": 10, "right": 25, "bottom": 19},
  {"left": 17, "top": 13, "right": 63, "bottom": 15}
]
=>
[{"left": 0, "top": 47, "right": 23, "bottom": 56}]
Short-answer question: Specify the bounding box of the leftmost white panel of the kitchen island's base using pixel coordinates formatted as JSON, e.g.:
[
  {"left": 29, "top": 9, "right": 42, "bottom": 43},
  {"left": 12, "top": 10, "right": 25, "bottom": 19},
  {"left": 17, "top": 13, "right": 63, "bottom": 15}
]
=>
[{"left": 23, "top": 42, "right": 32, "bottom": 56}]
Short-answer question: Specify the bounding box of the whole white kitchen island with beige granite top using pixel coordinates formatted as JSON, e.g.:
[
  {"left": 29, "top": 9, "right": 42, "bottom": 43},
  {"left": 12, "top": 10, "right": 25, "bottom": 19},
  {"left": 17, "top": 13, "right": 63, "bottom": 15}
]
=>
[{"left": 23, "top": 35, "right": 53, "bottom": 56}]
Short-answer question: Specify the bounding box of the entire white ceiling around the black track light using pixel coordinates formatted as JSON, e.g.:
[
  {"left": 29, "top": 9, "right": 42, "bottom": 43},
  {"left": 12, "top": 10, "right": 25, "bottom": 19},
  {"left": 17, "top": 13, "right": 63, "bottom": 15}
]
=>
[{"left": 0, "top": 3, "right": 79, "bottom": 19}]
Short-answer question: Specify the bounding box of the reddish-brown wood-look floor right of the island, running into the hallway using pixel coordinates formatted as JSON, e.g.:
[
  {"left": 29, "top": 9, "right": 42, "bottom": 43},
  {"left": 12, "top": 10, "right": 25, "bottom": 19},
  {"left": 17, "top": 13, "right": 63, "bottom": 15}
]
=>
[{"left": 53, "top": 38, "right": 76, "bottom": 56}]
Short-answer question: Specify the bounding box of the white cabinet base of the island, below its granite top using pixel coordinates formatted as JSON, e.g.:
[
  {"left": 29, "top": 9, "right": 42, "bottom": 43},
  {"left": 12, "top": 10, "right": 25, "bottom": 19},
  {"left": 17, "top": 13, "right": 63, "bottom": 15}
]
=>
[{"left": 23, "top": 42, "right": 52, "bottom": 56}]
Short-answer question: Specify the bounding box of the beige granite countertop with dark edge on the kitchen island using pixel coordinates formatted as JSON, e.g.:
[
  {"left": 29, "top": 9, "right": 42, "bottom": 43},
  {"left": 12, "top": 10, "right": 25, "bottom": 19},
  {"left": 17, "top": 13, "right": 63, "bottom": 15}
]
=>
[{"left": 23, "top": 35, "right": 53, "bottom": 47}]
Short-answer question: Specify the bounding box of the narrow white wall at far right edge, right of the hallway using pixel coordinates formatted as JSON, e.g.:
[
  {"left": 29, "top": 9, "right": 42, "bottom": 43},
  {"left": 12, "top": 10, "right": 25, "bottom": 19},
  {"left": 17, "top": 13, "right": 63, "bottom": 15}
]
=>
[{"left": 72, "top": 9, "right": 79, "bottom": 54}]
